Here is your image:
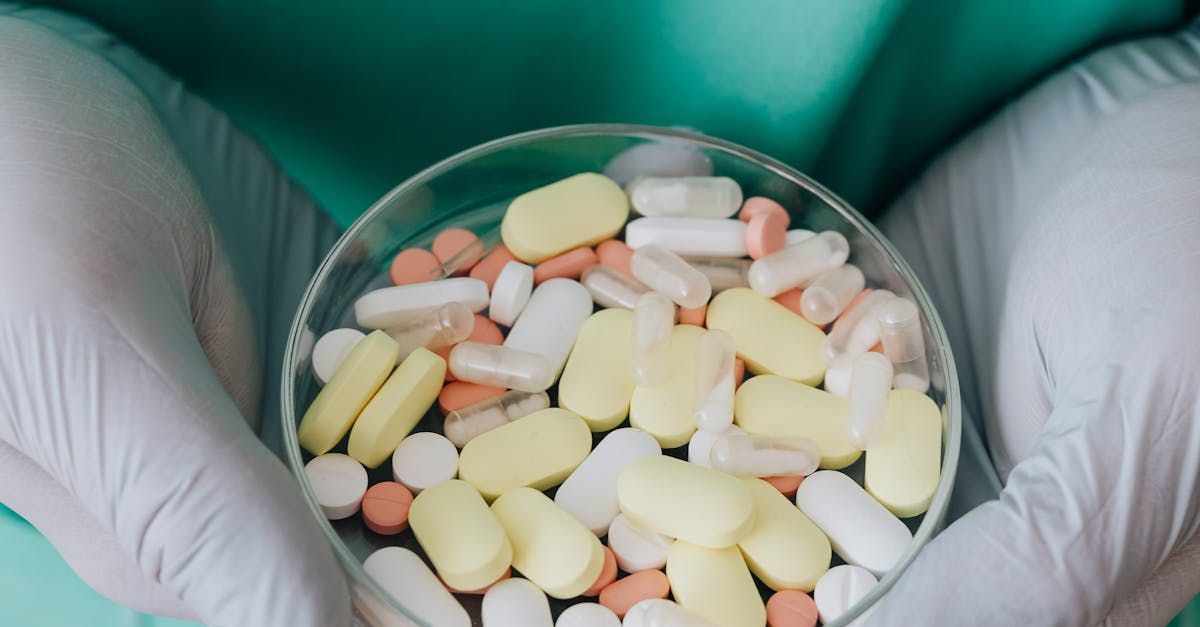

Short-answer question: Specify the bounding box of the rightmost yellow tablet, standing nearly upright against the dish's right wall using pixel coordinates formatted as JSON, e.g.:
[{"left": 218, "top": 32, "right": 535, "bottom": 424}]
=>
[{"left": 863, "top": 389, "right": 942, "bottom": 518}]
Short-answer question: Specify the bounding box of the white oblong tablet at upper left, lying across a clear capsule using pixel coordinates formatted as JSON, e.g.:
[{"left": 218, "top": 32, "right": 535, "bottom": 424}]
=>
[{"left": 354, "top": 276, "right": 491, "bottom": 329}]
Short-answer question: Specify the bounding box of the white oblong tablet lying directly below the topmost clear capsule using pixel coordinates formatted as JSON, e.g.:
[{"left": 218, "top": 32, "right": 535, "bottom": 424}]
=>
[{"left": 625, "top": 217, "right": 746, "bottom": 257}]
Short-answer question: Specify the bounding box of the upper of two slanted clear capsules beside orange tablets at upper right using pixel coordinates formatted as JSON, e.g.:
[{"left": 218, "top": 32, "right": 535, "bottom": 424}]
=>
[{"left": 748, "top": 231, "right": 850, "bottom": 298}]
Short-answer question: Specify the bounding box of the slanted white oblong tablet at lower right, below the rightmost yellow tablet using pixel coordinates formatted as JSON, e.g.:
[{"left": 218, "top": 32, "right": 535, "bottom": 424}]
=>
[{"left": 796, "top": 471, "right": 912, "bottom": 577}]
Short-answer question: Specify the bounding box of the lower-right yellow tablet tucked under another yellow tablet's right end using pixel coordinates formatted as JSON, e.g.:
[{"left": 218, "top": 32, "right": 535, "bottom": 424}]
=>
[{"left": 738, "top": 477, "right": 833, "bottom": 592}]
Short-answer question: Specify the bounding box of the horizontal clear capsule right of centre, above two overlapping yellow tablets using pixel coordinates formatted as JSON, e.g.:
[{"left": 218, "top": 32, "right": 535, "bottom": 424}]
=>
[{"left": 708, "top": 434, "right": 821, "bottom": 477}]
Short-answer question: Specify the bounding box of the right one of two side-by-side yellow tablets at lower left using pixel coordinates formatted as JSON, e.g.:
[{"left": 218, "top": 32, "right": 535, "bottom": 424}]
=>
[{"left": 492, "top": 488, "right": 604, "bottom": 598}]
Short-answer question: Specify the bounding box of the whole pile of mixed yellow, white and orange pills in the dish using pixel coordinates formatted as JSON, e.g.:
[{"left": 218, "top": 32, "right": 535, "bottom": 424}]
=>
[{"left": 298, "top": 165, "right": 942, "bottom": 627}]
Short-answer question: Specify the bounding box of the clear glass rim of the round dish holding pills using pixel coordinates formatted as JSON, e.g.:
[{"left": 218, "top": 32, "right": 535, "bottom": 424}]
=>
[{"left": 280, "top": 124, "right": 962, "bottom": 626}]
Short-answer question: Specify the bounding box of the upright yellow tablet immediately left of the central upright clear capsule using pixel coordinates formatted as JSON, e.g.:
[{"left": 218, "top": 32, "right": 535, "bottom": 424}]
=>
[{"left": 558, "top": 309, "right": 634, "bottom": 431}]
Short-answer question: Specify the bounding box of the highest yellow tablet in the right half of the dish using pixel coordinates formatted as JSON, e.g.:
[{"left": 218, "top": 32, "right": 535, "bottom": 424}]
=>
[{"left": 706, "top": 287, "right": 827, "bottom": 386}]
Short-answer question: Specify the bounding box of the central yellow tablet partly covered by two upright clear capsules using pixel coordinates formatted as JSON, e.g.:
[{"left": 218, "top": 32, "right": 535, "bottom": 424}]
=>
[{"left": 629, "top": 324, "right": 704, "bottom": 448}]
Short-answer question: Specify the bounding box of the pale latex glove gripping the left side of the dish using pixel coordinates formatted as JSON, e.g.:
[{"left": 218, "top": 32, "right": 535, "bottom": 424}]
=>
[{"left": 0, "top": 16, "right": 349, "bottom": 627}]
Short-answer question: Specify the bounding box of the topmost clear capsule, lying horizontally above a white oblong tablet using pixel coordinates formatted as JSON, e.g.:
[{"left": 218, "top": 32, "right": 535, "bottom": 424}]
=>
[{"left": 625, "top": 177, "right": 742, "bottom": 219}]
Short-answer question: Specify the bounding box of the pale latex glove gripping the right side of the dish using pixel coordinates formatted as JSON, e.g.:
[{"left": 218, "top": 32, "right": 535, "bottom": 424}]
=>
[{"left": 870, "top": 19, "right": 1200, "bottom": 626}]
